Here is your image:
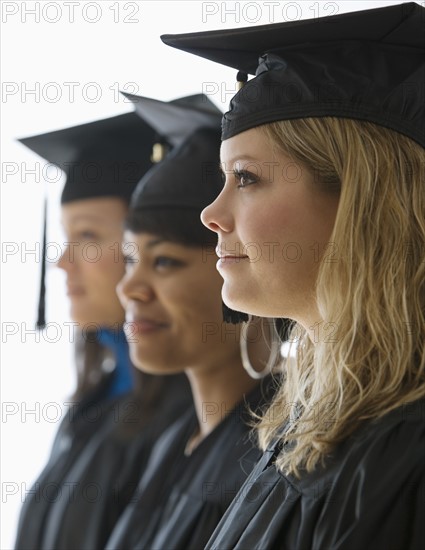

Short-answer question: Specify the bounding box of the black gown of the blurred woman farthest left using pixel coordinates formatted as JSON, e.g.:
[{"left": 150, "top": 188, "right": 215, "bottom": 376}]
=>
[{"left": 15, "top": 364, "right": 192, "bottom": 550}]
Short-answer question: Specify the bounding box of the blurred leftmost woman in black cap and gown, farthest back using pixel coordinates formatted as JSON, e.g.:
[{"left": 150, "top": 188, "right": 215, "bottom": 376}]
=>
[{"left": 16, "top": 113, "right": 189, "bottom": 550}]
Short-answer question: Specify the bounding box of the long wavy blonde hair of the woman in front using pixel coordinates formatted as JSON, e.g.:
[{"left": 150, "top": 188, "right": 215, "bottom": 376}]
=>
[{"left": 259, "top": 117, "right": 425, "bottom": 476}]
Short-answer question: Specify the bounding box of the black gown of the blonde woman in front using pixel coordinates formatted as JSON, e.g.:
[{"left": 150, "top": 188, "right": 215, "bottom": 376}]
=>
[{"left": 206, "top": 400, "right": 425, "bottom": 550}]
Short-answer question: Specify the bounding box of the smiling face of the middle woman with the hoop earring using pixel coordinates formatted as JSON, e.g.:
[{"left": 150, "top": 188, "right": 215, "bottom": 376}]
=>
[{"left": 117, "top": 232, "right": 239, "bottom": 373}]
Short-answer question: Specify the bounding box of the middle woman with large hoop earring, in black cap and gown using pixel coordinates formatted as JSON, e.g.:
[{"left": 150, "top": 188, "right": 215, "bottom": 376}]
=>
[{"left": 102, "top": 98, "right": 270, "bottom": 550}]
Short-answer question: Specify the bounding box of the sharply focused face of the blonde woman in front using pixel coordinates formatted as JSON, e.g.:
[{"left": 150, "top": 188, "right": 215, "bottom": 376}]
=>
[{"left": 202, "top": 128, "right": 338, "bottom": 326}]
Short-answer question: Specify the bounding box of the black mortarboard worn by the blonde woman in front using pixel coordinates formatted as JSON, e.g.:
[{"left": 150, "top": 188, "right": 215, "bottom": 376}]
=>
[{"left": 161, "top": 2, "right": 425, "bottom": 146}]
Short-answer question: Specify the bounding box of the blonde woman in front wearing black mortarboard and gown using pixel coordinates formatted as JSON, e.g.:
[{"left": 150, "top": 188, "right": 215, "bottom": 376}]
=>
[{"left": 165, "top": 3, "right": 425, "bottom": 550}]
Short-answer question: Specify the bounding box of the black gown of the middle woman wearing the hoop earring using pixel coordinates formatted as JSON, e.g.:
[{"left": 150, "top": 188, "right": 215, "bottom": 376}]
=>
[{"left": 106, "top": 380, "right": 271, "bottom": 550}]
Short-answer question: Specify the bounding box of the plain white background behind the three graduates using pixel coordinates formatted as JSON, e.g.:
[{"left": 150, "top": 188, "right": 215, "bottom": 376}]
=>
[{"left": 0, "top": 0, "right": 410, "bottom": 550}]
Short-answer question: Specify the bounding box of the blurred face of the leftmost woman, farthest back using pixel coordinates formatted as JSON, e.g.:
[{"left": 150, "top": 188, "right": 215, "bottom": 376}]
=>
[{"left": 58, "top": 197, "right": 127, "bottom": 328}]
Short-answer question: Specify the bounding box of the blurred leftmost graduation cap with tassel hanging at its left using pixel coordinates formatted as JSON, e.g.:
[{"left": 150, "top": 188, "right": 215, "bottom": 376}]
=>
[{"left": 18, "top": 113, "right": 154, "bottom": 328}]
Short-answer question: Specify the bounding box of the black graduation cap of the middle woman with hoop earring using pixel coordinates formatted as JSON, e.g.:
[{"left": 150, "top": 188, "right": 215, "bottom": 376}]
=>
[{"left": 124, "top": 94, "right": 246, "bottom": 322}]
